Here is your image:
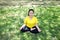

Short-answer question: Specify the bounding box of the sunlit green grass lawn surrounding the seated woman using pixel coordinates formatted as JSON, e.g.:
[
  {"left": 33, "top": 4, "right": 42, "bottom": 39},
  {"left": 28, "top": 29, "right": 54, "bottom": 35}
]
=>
[{"left": 0, "top": 6, "right": 60, "bottom": 40}]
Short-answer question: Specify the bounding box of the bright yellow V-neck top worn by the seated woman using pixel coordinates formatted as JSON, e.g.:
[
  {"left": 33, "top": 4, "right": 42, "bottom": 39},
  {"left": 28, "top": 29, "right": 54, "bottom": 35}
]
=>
[{"left": 24, "top": 16, "right": 38, "bottom": 28}]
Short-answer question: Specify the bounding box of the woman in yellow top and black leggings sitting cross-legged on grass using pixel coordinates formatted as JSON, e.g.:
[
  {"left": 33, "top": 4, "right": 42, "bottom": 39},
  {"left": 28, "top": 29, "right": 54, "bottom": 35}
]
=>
[{"left": 20, "top": 9, "right": 41, "bottom": 34}]
